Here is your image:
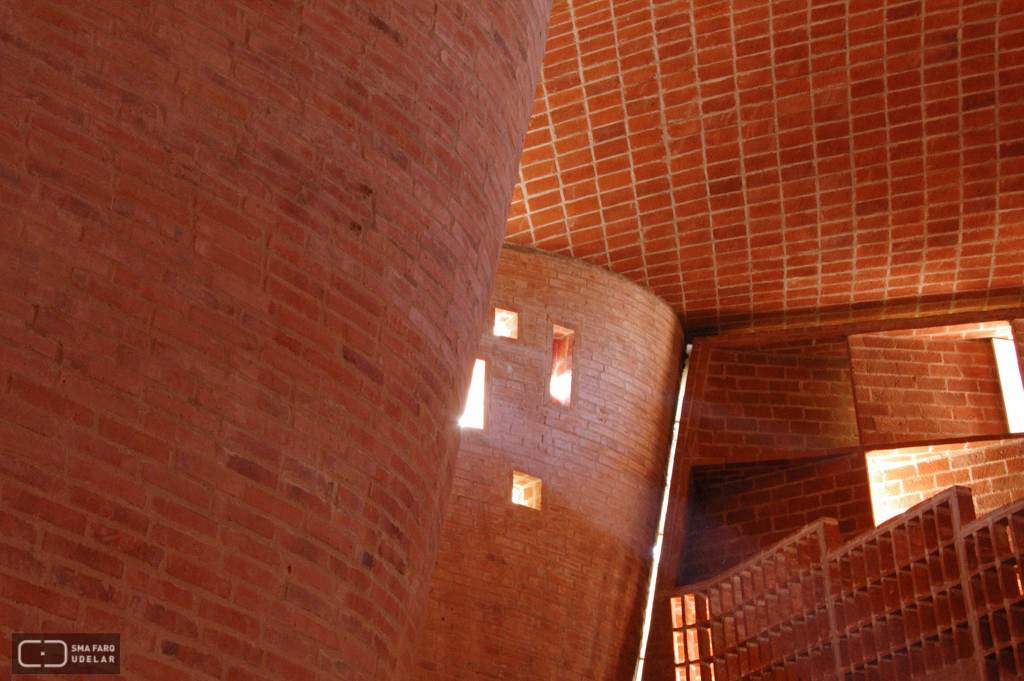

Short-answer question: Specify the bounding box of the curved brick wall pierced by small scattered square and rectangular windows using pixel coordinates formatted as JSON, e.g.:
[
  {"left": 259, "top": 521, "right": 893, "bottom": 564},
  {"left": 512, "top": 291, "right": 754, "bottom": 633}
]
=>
[{"left": 417, "top": 245, "right": 682, "bottom": 681}]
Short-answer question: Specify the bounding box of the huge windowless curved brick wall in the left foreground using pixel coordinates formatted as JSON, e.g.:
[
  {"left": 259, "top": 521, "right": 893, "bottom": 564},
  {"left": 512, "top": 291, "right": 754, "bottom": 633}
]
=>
[{"left": 0, "top": 0, "right": 550, "bottom": 681}]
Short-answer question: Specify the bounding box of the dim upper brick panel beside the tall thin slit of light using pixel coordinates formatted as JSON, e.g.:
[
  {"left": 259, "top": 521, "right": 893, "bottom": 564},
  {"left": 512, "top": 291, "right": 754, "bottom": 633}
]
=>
[{"left": 687, "top": 343, "right": 858, "bottom": 465}]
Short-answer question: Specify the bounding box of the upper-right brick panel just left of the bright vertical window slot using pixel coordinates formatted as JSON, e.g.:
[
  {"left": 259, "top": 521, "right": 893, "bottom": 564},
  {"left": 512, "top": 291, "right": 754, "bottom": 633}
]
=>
[{"left": 850, "top": 335, "right": 1008, "bottom": 445}]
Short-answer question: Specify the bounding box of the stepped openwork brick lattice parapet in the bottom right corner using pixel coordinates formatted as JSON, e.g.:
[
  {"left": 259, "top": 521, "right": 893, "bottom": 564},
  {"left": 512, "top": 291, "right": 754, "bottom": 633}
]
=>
[{"left": 663, "top": 486, "right": 1024, "bottom": 681}]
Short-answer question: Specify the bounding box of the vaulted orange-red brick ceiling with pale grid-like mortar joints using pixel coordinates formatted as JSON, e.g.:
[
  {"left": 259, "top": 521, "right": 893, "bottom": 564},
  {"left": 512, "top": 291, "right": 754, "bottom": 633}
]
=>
[{"left": 506, "top": 0, "right": 1024, "bottom": 332}]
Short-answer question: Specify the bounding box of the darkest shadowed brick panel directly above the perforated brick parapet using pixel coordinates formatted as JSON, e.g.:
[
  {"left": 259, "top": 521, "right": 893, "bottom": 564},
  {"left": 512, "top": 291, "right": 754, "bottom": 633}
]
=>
[{"left": 678, "top": 452, "right": 874, "bottom": 584}]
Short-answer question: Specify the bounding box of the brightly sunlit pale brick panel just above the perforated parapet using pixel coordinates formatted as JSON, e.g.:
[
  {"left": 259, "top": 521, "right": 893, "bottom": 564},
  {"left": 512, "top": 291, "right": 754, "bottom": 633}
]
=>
[{"left": 866, "top": 439, "right": 1024, "bottom": 522}]
